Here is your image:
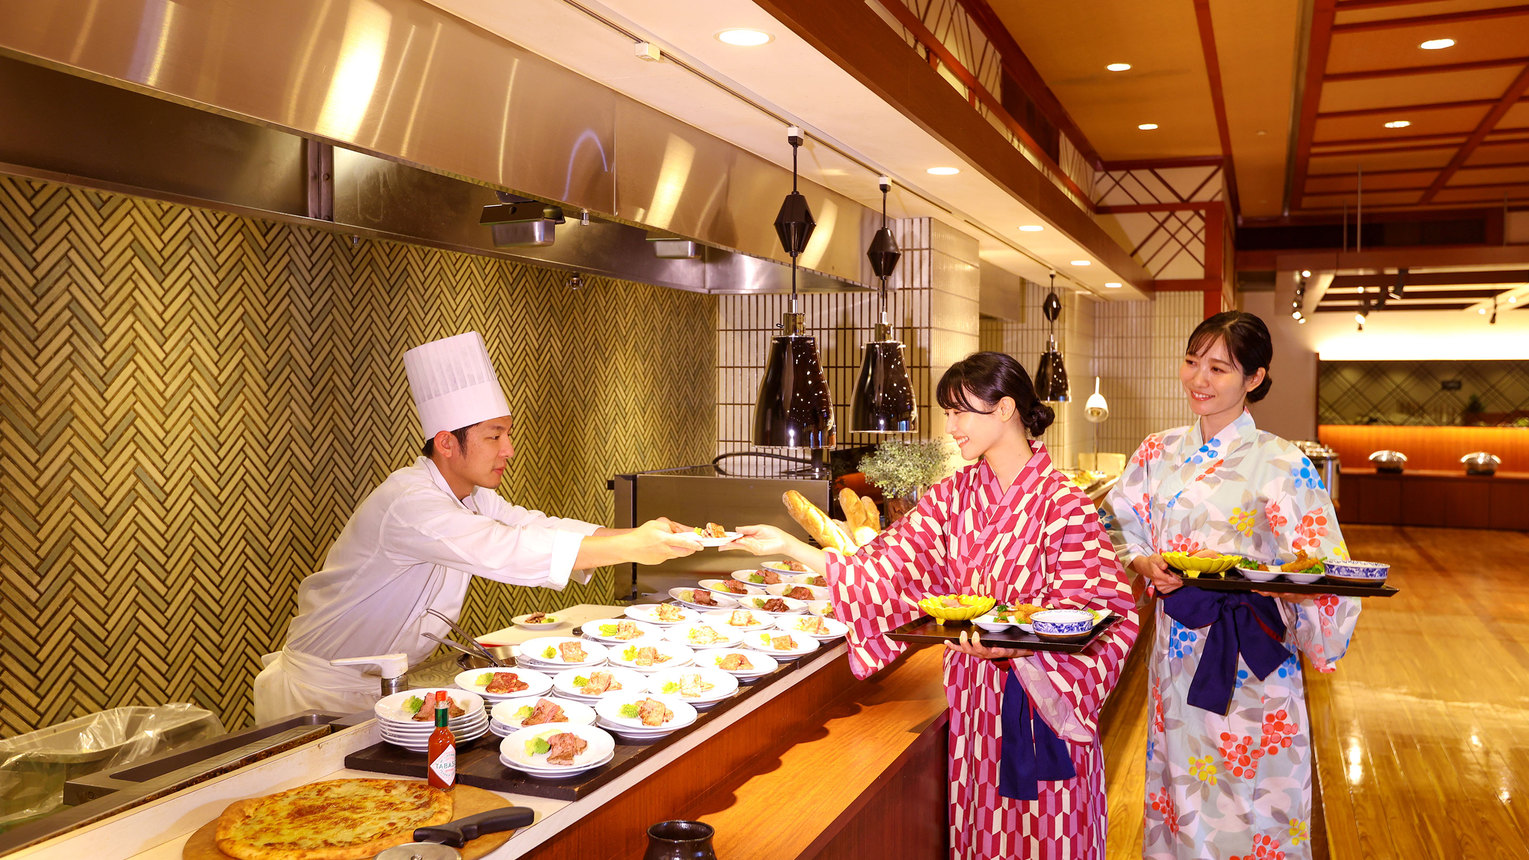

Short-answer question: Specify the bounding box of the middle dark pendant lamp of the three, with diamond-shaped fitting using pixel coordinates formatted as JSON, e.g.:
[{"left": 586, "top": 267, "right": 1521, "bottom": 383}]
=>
[{"left": 850, "top": 176, "right": 919, "bottom": 433}]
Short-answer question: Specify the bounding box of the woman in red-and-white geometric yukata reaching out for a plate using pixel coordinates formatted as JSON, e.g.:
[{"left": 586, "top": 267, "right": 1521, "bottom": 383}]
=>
[{"left": 735, "top": 352, "right": 1138, "bottom": 860}]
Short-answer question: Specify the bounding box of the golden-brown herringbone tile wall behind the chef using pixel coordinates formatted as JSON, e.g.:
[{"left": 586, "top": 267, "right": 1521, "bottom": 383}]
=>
[{"left": 0, "top": 176, "right": 717, "bottom": 736}]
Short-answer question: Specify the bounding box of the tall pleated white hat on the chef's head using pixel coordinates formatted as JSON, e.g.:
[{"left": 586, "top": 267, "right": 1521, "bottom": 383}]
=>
[{"left": 404, "top": 332, "right": 509, "bottom": 439}]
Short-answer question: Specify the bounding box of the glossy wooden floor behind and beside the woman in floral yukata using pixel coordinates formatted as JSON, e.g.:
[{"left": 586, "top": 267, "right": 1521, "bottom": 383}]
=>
[{"left": 1105, "top": 526, "right": 1529, "bottom": 860}]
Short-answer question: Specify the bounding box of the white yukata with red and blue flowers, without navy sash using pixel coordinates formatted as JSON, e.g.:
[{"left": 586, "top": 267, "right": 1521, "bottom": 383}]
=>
[{"left": 1109, "top": 412, "right": 1359, "bottom": 860}]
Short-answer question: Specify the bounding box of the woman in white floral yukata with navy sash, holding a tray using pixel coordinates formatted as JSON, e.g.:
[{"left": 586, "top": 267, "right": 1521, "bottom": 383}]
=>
[{"left": 1109, "top": 311, "right": 1359, "bottom": 860}]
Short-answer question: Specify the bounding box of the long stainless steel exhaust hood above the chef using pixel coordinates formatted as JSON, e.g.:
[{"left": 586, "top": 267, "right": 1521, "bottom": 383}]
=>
[{"left": 0, "top": 0, "right": 876, "bottom": 292}]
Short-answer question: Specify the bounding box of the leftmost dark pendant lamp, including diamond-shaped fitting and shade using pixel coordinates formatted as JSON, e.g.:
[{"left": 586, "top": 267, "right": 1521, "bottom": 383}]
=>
[{"left": 754, "top": 125, "right": 835, "bottom": 448}]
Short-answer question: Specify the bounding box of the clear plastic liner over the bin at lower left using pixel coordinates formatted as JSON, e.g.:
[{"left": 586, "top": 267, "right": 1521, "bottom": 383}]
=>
[{"left": 0, "top": 702, "right": 225, "bottom": 831}]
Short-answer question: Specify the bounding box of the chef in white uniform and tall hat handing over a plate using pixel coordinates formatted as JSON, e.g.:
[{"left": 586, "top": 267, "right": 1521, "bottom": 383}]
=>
[{"left": 255, "top": 332, "right": 700, "bottom": 722}]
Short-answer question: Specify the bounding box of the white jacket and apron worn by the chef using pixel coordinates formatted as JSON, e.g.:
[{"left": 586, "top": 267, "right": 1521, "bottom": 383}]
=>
[{"left": 255, "top": 458, "right": 599, "bottom": 722}]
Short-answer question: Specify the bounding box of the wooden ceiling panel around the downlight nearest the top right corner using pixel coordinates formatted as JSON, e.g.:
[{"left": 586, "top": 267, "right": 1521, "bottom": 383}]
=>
[{"left": 1327, "top": 14, "right": 1529, "bottom": 75}]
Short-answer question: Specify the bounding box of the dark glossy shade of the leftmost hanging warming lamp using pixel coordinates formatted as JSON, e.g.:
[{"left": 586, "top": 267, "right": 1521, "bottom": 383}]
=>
[{"left": 754, "top": 327, "right": 835, "bottom": 448}]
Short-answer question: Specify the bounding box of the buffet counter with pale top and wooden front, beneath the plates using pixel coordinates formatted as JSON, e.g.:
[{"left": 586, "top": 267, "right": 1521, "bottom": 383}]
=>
[{"left": 12, "top": 604, "right": 945, "bottom": 860}]
